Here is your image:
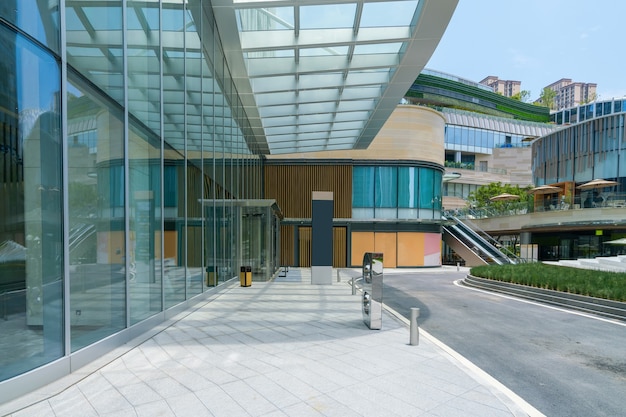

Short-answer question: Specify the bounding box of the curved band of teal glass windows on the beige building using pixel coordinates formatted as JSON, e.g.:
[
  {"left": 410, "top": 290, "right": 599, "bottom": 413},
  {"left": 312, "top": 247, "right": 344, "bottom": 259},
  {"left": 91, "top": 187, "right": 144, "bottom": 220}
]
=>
[{"left": 352, "top": 166, "right": 443, "bottom": 219}]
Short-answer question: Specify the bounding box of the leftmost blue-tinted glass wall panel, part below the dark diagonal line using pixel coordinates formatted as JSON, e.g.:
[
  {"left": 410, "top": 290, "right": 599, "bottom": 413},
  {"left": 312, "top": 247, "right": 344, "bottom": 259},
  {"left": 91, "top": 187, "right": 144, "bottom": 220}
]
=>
[{"left": 0, "top": 27, "right": 65, "bottom": 380}]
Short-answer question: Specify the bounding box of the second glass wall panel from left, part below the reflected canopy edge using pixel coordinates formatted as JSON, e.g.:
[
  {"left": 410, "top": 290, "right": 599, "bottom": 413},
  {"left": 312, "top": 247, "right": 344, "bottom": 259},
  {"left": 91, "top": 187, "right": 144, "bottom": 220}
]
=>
[{"left": 67, "top": 73, "right": 126, "bottom": 351}]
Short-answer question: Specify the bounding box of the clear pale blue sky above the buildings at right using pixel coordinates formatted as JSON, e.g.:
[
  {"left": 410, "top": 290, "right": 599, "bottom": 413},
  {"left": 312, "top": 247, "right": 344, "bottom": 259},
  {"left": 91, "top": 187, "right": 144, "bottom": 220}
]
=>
[{"left": 426, "top": 0, "right": 626, "bottom": 100}]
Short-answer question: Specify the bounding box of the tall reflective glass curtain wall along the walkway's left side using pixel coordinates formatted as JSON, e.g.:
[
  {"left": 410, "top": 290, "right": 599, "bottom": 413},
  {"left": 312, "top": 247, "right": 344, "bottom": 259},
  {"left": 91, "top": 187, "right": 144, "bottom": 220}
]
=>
[{"left": 0, "top": 0, "right": 278, "bottom": 393}]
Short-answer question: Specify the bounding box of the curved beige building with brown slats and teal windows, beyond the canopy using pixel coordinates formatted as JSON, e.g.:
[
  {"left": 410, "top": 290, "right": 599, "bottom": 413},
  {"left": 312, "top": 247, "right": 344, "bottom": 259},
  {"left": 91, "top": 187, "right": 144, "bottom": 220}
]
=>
[{"left": 265, "top": 105, "right": 445, "bottom": 267}]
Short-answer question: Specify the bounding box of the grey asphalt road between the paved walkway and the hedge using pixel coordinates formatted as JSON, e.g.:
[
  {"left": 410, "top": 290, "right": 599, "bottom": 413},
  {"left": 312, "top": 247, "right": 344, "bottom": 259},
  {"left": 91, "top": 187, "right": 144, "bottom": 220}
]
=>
[{"left": 383, "top": 271, "right": 626, "bottom": 417}]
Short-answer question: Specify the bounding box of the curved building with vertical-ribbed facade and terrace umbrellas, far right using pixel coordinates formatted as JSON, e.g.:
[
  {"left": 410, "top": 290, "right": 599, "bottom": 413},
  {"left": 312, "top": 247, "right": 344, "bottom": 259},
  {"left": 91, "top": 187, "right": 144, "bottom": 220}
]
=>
[{"left": 522, "top": 112, "right": 626, "bottom": 260}]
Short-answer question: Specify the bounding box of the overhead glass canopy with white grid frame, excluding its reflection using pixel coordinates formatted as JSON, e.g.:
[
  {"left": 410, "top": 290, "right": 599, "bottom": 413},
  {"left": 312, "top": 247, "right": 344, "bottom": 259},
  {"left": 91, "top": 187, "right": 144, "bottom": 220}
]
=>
[{"left": 212, "top": 0, "right": 458, "bottom": 154}]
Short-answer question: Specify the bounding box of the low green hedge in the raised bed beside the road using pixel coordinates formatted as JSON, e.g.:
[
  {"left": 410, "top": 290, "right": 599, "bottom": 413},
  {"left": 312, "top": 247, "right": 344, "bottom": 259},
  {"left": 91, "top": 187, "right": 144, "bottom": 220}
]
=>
[{"left": 470, "top": 263, "right": 626, "bottom": 301}]
